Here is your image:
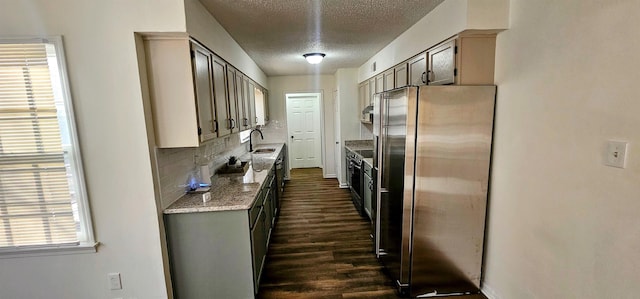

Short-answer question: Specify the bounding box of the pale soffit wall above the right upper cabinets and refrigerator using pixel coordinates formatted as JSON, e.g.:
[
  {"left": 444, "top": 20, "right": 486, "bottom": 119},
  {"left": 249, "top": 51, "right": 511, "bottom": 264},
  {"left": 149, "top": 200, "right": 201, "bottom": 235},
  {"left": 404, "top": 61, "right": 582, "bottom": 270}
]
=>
[{"left": 358, "top": 0, "right": 509, "bottom": 82}]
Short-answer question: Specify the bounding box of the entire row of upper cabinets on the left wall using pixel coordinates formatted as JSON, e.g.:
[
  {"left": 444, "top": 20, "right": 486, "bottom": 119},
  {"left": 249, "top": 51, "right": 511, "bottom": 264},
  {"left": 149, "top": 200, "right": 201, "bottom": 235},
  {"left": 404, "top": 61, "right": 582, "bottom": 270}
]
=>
[{"left": 144, "top": 36, "right": 268, "bottom": 148}]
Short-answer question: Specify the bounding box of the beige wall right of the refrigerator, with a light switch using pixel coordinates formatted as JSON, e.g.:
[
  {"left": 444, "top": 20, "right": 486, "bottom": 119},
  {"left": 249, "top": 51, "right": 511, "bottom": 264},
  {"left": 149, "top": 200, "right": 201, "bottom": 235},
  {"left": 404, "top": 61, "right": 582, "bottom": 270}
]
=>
[{"left": 485, "top": 0, "right": 640, "bottom": 298}]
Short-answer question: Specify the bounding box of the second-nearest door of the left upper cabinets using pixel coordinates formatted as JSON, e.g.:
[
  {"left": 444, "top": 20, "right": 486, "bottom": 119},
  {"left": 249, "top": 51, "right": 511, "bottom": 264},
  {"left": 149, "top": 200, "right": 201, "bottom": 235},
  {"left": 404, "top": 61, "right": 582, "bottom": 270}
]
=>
[{"left": 212, "top": 56, "right": 231, "bottom": 137}]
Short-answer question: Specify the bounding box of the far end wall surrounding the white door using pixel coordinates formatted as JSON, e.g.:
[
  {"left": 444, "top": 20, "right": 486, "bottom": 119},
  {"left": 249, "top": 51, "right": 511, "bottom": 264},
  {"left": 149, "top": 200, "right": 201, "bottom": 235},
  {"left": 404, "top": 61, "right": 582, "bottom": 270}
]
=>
[{"left": 260, "top": 75, "right": 336, "bottom": 177}]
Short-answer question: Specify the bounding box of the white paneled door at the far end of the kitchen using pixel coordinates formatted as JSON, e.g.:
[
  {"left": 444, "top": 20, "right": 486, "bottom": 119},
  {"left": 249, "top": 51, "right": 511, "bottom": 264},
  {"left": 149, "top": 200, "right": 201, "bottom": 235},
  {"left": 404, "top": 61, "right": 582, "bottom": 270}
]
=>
[{"left": 286, "top": 93, "right": 322, "bottom": 168}]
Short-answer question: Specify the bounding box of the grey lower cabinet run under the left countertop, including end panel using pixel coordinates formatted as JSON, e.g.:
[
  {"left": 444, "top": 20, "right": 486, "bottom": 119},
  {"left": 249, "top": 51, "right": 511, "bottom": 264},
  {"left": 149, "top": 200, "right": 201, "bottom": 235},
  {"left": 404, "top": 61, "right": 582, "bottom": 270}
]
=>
[{"left": 164, "top": 167, "right": 277, "bottom": 298}]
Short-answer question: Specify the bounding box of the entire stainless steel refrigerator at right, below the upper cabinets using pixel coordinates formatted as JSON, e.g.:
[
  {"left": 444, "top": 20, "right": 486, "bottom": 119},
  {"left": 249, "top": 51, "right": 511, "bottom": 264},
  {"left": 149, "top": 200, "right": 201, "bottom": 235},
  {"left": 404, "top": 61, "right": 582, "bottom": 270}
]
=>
[{"left": 374, "top": 85, "right": 496, "bottom": 297}]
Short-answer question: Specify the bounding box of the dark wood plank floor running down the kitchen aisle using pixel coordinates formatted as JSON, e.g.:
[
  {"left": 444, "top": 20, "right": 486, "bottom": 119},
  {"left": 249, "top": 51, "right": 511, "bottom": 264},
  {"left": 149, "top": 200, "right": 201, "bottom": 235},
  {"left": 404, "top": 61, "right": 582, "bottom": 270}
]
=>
[{"left": 258, "top": 168, "right": 485, "bottom": 299}]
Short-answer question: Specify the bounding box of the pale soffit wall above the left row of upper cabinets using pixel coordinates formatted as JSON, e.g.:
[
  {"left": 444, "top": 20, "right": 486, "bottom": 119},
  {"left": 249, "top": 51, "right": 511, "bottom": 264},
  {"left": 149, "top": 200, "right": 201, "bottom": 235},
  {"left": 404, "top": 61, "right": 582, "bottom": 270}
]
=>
[{"left": 184, "top": 0, "right": 268, "bottom": 89}]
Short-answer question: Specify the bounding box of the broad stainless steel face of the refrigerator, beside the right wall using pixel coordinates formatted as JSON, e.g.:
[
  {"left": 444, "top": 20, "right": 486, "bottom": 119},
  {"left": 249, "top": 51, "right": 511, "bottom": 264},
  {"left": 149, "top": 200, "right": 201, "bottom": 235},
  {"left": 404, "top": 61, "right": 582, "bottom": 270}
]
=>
[{"left": 411, "top": 86, "right": 496, "bottom": 296}]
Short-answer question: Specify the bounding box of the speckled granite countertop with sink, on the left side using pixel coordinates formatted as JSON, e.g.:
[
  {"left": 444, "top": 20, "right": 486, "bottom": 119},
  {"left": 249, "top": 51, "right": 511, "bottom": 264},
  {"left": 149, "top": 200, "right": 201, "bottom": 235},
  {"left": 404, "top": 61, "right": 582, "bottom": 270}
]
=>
[{"left": 164, "top": 143, "right": 284, "bottom": 214}]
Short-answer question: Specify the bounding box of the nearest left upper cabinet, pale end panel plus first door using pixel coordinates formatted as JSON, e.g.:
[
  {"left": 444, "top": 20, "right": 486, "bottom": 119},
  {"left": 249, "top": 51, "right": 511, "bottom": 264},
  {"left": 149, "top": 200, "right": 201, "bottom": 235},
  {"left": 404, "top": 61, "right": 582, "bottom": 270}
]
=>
[{"left": 144, "top": 36, "right": 210, "bottom": 148}]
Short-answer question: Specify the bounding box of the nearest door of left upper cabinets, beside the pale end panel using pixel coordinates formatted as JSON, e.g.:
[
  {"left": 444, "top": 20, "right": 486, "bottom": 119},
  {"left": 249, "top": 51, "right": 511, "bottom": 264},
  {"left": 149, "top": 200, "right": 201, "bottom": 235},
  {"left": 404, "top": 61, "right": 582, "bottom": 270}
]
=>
[{"left": 191, "top": 44, "right": 217, "bottom": 142}]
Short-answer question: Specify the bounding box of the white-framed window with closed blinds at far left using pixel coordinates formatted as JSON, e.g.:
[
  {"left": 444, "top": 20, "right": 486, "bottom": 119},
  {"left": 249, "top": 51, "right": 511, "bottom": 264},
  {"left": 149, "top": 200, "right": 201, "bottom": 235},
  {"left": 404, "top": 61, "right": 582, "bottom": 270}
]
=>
[{"left": 0, "top": 37, "right": 95, "bottom": 255}]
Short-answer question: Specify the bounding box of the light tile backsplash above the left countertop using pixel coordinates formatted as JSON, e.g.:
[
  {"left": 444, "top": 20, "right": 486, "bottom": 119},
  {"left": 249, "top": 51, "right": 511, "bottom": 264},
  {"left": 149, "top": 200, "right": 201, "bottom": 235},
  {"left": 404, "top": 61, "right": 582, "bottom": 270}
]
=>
[{"left": 156, "top": 134, "right": 247, "bottom": 209}]
